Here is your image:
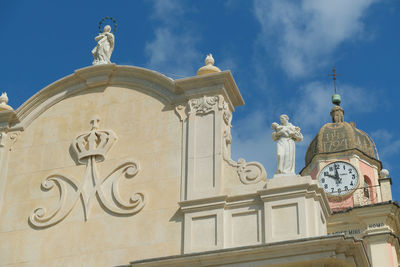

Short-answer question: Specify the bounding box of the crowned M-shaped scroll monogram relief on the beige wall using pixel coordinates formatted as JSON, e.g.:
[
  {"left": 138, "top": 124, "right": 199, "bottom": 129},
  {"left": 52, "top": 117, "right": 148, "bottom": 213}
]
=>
[{"left": 29, "top": 117, "right": 145, "bottom": 227}]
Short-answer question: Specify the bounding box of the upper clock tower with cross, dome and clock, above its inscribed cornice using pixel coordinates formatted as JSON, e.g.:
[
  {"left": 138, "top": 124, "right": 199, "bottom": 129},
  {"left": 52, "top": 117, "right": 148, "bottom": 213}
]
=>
[{"left": 301, "top": 69, "right": 391, "bottom": 214}]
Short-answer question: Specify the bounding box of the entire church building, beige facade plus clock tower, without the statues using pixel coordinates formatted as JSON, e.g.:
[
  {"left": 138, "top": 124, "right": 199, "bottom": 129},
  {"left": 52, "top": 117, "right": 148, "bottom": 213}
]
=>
[{"left": 0, "top": 30, "right": 400, "bottom": 267}]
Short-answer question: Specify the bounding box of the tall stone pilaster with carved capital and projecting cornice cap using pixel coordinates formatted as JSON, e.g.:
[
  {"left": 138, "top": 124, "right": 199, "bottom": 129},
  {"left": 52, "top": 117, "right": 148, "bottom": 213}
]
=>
[{"left": 175, "top": 71, "right": 244, "bottom": 200}]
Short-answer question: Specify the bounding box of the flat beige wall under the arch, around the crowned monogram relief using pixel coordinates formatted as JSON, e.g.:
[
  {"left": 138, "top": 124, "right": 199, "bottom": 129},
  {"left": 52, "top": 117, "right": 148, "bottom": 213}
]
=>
[{"left": 0, "top": 86, "right": 182, "bottom": 266}]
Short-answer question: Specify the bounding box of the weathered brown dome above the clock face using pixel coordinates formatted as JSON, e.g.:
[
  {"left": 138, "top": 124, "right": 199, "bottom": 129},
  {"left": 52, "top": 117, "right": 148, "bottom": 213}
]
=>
[{"left": 305, "top": 106, "right": 377, "bottom": 166}]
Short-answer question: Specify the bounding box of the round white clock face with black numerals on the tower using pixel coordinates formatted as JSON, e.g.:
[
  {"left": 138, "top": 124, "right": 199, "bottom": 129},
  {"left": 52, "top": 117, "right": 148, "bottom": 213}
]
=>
[{"left": 318, "top": 161, "right": 358, "bottom": 196}]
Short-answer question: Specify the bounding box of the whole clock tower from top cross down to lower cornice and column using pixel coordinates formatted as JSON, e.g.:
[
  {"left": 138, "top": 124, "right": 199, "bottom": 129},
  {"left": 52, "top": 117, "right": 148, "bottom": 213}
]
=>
[{"left": 300, "top": 68, "right": 400, "bottom": 267}]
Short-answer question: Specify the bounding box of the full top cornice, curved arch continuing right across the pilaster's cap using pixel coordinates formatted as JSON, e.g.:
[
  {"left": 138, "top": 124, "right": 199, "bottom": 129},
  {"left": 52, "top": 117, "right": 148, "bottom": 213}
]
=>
[{"left": 10, "top": 64, "right": 244, "bottom": 130}]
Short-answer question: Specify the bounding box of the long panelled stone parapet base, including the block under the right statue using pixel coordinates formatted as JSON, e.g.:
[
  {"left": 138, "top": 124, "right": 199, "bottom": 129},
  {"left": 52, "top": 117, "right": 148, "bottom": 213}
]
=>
[{"left": 179, "top": 175, "right": 330, "bottom": 253}]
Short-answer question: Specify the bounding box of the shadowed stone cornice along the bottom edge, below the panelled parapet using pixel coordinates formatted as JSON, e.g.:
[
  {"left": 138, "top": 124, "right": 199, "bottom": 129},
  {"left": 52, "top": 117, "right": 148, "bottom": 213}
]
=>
[{"left": 127, "top": 235, "right": 371, "bottom": 267}]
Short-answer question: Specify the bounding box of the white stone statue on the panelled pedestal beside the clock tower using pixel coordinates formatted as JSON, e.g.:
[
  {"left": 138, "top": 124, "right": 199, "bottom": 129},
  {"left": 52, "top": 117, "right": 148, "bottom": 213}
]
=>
[{"left": 272, "top": 114, "right": 303, "bottom": 174}]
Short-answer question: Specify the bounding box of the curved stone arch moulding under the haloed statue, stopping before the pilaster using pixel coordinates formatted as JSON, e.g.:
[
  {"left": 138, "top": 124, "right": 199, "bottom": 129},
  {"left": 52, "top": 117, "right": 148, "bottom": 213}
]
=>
[{"left": 12, "top": 64, "right": 177, "bottom": 129}]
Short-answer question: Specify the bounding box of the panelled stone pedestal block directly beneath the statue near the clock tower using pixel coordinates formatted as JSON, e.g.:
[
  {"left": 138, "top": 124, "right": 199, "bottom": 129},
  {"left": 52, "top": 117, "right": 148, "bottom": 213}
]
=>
[{"left": 258, "top": 175, "right": 330, "bottom": 243}]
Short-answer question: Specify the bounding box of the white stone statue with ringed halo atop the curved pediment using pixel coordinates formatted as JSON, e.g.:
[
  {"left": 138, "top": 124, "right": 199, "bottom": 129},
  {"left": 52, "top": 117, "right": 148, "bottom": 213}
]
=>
[{"left": 92, "top": 25, "right": 114, "bottom": 65}]
